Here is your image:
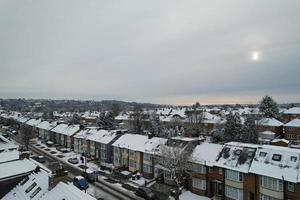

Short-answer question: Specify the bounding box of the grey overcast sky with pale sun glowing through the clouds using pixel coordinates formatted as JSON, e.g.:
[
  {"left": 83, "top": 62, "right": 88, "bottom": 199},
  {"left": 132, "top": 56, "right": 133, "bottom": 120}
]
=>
[{"left": 0, "top": 0, "right": 300, "bottom": 104}]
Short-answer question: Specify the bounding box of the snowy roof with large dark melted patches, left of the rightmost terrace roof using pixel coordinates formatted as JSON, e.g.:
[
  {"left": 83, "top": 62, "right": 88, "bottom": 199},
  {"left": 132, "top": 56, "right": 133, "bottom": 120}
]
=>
[{"left": 215, "top": 142, "right": 258, "bottom": 173}]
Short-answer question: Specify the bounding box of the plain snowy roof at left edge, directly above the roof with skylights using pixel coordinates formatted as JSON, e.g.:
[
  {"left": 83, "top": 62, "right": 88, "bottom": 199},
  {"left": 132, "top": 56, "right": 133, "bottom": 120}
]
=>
[{"left": 0, "top": 159, "right": 36, "bottom": 179}]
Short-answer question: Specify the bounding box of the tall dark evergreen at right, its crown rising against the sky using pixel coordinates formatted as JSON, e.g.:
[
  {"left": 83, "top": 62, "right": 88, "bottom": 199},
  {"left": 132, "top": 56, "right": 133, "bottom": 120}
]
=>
[{"left": 259, "top": 95, "right": 279, "bottom": 118}]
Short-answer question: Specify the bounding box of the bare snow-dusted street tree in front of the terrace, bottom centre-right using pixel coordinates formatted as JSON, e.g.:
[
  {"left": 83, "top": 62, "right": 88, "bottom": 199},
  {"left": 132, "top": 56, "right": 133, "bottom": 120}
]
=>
[{"left": 155, "top": 144, "right": 190, "bottom": 200}]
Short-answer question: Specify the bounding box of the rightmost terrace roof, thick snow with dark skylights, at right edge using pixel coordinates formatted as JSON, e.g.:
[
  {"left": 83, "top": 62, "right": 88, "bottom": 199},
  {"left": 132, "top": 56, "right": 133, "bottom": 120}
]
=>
[{"left": 249, "top": 145, "right": 300, "bottom": 183}]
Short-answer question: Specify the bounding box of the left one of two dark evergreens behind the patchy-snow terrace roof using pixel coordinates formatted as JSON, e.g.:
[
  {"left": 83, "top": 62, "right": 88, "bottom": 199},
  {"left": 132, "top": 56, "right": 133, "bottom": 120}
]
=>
[{"left": 224, "top": 112, "right": 242, "bottom": 142}]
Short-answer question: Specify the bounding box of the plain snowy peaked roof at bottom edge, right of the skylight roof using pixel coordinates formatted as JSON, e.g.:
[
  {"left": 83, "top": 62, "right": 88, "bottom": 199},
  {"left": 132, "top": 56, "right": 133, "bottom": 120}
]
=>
[{"left": 41, "top": 182, "right": 96, "bottom": 200}]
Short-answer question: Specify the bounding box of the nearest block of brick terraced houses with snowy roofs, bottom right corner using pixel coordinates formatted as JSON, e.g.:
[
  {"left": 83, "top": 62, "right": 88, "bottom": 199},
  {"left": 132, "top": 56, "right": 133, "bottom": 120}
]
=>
[{"left": 190, "top": 142, "right": 300, "bottom": 200}]
